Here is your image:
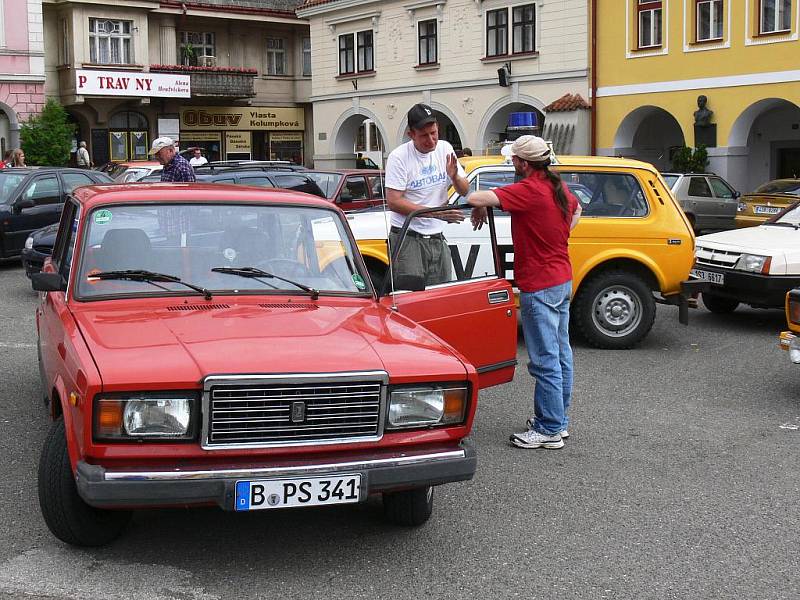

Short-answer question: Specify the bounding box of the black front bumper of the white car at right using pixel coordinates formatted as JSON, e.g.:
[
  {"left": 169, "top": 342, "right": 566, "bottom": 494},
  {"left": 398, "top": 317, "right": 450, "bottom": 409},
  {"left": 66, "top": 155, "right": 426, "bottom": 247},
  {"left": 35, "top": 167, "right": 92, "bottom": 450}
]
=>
[{"left": 695, "top": 265, "right": 800, "bottom": 308}]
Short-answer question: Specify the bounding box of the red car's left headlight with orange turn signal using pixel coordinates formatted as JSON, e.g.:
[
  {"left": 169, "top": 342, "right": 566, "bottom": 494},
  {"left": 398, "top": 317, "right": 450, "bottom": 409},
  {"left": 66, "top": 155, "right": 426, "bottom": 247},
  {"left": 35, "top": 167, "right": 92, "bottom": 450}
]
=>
[{"left": 94, "top": 392, "right": 199, "bottom": 440}]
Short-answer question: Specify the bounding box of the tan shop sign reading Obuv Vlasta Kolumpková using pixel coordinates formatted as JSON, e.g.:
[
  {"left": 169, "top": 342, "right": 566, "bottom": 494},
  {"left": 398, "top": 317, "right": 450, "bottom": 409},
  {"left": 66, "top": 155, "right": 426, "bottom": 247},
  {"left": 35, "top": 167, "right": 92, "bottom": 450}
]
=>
[{"left": 181, "top": 106, "right": 306, "bottom": 131}]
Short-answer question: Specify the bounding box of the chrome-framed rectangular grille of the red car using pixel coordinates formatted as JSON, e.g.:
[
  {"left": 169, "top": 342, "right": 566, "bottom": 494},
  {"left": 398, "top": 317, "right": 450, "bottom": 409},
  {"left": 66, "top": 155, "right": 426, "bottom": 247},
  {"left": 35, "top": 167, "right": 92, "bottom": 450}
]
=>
[{"left": 204, "top": 373, "right": 386, "bottom": 448}]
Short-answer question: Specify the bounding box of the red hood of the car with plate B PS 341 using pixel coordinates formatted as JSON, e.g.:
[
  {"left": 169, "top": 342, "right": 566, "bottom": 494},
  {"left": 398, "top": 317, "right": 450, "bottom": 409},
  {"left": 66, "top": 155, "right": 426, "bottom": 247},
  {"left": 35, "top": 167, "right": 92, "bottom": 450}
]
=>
[{"left": 73, "top": 297, "right": 466, "bottom": 391}]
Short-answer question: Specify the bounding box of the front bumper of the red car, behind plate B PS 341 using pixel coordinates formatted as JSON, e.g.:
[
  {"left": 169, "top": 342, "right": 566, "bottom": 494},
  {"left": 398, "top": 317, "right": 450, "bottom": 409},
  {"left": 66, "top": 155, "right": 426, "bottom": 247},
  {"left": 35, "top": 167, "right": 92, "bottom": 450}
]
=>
[{"left": 76, "top": 440, "right": 478, "bottom": 510}]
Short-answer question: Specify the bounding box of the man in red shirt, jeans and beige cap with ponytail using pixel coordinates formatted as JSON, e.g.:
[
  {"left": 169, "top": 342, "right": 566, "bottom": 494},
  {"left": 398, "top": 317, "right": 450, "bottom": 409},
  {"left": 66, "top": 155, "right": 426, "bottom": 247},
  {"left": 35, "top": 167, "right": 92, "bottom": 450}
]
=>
[{"left": 467, "top": 135, "right": 581, "bottom": 448}]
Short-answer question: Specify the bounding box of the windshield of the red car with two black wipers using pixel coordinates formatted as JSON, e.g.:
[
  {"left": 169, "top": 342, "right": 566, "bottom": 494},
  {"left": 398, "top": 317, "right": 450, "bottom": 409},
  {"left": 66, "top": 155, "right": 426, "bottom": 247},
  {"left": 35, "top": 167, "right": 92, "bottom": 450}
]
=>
[{"left": 76, "top": 203, "right": 369, "bottom": 299}]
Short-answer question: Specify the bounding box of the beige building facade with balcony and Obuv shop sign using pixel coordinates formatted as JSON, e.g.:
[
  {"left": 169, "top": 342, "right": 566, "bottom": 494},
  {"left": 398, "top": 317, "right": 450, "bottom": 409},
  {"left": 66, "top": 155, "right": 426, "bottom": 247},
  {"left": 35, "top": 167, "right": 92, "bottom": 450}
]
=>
[{"left": 43, "top": 0, "right": 313, "bottom": 164}]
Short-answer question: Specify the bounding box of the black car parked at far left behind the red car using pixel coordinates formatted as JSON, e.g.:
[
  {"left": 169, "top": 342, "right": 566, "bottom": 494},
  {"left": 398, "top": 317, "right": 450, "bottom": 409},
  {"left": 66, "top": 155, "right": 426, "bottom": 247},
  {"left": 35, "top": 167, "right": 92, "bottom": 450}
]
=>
[{"left": 0, "top": 167, "right": 113, "bottom": 258}]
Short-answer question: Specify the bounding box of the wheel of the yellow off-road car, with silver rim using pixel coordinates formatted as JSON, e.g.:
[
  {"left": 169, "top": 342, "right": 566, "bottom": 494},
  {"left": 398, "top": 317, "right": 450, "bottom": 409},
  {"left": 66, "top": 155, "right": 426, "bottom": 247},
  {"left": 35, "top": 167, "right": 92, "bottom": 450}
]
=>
[{"left": 571, "top": 269, "right": 656, "bottom": 350}]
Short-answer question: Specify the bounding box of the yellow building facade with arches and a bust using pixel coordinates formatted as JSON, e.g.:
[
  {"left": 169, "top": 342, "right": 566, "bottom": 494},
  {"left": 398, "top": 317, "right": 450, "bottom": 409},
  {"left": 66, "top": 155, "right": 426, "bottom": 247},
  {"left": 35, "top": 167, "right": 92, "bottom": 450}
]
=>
[{"left": 593, "top": 0, "right": 800, "bottom": 192}]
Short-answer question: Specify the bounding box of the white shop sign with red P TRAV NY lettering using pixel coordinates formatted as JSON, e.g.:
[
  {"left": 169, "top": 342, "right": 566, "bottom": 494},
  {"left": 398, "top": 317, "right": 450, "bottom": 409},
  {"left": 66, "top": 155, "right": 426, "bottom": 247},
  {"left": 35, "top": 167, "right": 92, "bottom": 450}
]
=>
[{"left": 75, "top": 69, "right": 192, "bottom": 98}]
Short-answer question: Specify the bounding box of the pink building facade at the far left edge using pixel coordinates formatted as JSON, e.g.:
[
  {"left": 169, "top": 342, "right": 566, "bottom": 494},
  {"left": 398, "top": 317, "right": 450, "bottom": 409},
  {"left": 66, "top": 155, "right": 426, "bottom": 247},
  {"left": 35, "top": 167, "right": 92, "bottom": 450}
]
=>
[{"left": 0, "top": 0, "right": 45, "bottom": 152}]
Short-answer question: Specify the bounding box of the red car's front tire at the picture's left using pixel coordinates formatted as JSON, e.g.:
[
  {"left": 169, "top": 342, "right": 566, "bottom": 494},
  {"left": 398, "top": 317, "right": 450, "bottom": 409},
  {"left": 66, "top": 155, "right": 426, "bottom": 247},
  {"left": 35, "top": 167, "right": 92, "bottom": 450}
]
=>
[{"left": 39, "top": 417, "right": 132, "bottom": 546}]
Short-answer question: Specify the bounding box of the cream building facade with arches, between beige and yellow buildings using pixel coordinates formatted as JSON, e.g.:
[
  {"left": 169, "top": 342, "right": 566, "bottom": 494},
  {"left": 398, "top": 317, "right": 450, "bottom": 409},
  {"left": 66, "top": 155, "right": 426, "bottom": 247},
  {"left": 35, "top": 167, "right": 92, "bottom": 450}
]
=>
[{"left": 297, "top": 0, "right": 589, "bottom": 167}]
